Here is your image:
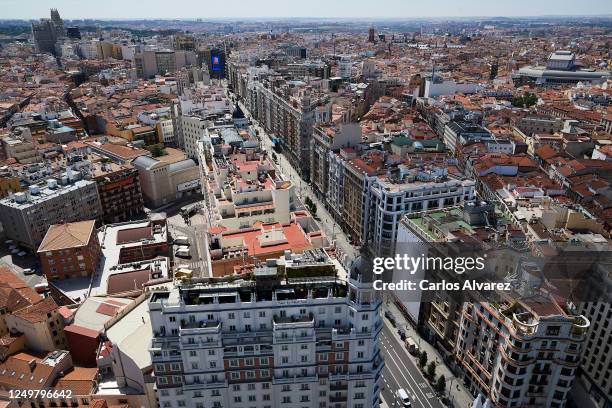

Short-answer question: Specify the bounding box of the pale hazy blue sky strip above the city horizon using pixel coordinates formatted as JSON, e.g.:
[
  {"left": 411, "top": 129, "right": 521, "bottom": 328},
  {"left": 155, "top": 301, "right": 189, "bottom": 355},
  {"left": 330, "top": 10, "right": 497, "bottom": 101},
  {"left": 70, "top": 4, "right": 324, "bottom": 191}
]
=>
[{"left": 0, "top": 0, "right": 612, "bottom": 19}]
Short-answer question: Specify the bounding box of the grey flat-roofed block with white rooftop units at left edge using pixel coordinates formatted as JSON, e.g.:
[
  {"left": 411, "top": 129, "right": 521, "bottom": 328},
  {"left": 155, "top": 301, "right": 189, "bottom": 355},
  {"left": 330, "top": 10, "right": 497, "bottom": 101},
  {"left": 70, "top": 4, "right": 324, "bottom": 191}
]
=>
[{"left": 0, "top": 176, "right": 102, "bottom": 250}]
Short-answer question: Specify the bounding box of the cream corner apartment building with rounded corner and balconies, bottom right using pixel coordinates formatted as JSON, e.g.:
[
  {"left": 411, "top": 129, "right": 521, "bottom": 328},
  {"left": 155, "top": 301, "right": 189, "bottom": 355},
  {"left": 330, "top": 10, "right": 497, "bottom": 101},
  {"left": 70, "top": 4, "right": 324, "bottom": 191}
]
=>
[{"left": 455, "top": 295, "right": 590, "bottom": 408}]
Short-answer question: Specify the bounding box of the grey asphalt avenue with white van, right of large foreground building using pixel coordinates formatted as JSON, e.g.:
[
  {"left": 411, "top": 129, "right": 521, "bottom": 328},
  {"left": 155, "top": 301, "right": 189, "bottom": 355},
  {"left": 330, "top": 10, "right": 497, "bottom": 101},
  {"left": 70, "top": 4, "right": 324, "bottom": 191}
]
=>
[{"left": 380, "top": 319, "right": 444, "bottom": 408}]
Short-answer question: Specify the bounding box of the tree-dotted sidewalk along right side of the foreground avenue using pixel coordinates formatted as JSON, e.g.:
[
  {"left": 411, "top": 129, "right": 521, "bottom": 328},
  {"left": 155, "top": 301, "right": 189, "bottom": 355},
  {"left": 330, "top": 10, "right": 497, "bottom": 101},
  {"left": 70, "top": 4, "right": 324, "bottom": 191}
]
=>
[{"left": 383, "top": 301, "right": 474, "bottom": 408}]
